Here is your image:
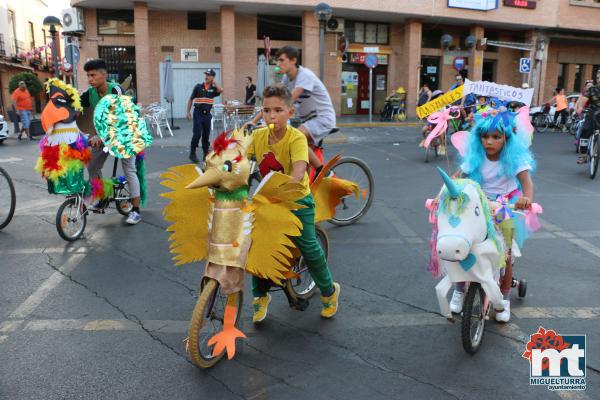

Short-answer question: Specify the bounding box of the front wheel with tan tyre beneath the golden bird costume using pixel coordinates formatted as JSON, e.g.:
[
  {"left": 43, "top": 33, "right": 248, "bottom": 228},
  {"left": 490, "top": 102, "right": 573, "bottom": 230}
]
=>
[{"left": 188, "top": 279, "right": 243, "bottom": 368}]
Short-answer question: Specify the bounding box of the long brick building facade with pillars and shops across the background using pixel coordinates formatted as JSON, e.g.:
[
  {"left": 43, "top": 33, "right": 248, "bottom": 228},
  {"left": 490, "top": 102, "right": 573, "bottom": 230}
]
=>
[{"left": 71, "top": 0, "right": 600, "bottom": 117}]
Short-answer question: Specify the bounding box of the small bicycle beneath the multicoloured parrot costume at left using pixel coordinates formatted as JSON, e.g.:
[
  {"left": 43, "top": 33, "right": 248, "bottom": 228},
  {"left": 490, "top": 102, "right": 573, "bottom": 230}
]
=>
[{"left": 55, "top": 158, "right": 133, "bottom": 242}]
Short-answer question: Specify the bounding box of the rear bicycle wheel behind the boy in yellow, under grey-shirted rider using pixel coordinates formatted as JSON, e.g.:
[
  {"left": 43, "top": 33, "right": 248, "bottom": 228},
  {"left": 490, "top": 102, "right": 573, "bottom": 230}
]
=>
[{"left": 329, "top": 157, "right": 375, "bottom": 226}]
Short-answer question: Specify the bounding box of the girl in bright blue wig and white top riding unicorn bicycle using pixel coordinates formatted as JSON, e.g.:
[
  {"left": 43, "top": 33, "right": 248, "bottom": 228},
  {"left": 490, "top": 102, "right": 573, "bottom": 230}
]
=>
[{"left": 450, "top": 107, "right": 535, "bottom": 322}]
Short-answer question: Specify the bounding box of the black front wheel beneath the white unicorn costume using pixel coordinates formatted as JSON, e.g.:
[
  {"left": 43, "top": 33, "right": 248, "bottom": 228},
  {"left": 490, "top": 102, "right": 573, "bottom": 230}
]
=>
[{"left": 461, "top": 282, "right": 487, "bottom": 354}]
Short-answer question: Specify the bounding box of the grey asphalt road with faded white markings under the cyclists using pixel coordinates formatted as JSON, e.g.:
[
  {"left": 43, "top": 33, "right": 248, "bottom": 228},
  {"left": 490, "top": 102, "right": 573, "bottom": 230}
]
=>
[{"left": 0, "top": 123, "right": 600, "bottom": 400}]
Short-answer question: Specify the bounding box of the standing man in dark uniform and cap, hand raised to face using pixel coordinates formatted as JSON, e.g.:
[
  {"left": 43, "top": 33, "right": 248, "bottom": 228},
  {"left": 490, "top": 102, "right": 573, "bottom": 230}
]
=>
[{"left": 187, "top": 69, "right": 223, "bottom": 163}]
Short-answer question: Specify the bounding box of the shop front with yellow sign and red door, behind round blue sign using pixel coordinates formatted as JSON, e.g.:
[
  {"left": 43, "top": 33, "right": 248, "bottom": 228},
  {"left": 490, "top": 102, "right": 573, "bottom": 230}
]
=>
[{"left": 341, "top": 45, "right": 391, "bottom": 115}]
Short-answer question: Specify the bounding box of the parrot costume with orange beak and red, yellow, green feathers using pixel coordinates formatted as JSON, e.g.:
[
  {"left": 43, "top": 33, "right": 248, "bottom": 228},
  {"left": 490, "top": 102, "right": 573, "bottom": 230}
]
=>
[{"left": 35, "top": 78, "right": 91, "bottom": 195}]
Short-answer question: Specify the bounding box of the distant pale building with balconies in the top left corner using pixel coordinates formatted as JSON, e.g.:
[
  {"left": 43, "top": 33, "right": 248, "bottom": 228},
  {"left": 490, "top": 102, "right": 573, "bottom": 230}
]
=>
[{"left": 0, "top": 0, "right": 58, "bottom": 116}]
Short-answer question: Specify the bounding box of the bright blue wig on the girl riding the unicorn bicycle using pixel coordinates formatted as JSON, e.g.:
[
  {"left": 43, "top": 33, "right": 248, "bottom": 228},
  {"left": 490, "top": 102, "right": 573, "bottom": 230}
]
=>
[{"left": 461, "top": 109, "right": 535, "bottom": 184}]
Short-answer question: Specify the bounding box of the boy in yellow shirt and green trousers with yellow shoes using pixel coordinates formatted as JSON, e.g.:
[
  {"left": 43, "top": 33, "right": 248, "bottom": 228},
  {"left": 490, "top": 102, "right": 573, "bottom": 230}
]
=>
[{"left": 247, "top": 85, "right": 340, "bottom": 323}]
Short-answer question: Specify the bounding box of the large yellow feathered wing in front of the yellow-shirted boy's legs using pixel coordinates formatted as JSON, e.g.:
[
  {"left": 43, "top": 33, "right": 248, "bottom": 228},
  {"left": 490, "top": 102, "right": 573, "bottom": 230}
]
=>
[{"left": 246, "top": 172, "right": 304, "bottom": 284}]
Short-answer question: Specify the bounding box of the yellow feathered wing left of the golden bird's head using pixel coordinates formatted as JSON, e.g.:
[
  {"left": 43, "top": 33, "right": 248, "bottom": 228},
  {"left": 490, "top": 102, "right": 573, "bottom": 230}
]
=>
[{"left": 160, "top": 164, "right": 212, "bottom": 265}]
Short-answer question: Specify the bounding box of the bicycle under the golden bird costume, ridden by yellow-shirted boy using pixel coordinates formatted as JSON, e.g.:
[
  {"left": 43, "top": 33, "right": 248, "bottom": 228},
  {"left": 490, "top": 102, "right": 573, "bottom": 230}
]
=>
[{"left": 187, "top": 225, "right": 329, "bottom": 368}]
